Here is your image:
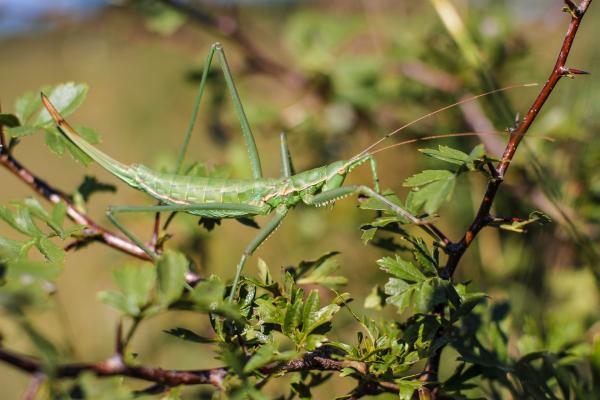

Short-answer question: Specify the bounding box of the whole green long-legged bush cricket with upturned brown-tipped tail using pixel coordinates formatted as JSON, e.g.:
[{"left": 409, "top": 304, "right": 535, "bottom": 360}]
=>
[{"left": 42, "top": 43, "right": 522, "bottom": 302}]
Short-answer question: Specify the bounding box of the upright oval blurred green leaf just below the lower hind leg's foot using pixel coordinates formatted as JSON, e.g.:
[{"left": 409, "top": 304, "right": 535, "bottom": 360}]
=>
[{"left": 156, "top": 250, "right": 189, "bottom": 307}]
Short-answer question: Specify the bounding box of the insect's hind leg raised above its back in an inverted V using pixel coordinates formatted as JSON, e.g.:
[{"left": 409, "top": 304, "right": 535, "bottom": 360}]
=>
[{"left": 176, "top": 43, "right": 262, "bottom": 179}]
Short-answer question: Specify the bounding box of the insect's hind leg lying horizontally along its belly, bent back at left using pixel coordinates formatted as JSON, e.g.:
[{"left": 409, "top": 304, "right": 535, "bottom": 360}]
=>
[{"left": 106, "top": 203, "right": 262, "bottom": 259}]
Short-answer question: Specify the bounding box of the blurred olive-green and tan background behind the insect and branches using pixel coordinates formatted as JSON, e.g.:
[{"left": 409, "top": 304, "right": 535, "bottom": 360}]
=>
[{"left": 0, "top": 0, "right": 600, "bottom": 399}]
